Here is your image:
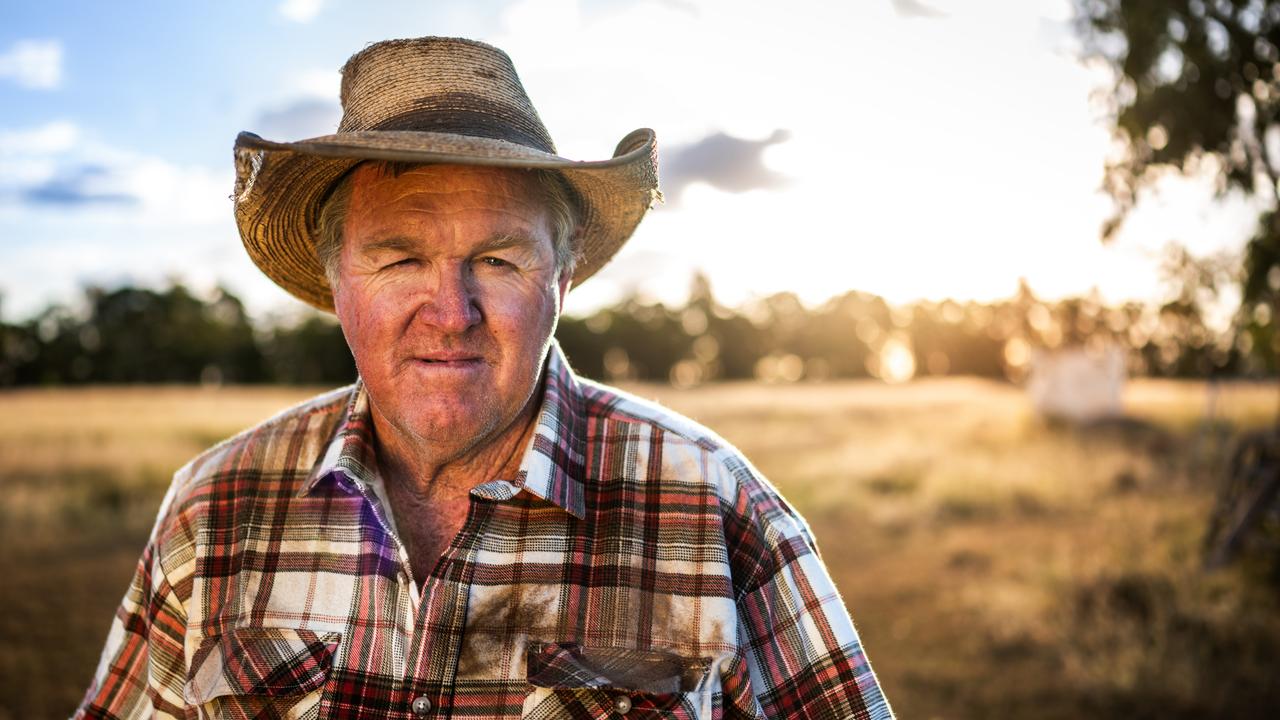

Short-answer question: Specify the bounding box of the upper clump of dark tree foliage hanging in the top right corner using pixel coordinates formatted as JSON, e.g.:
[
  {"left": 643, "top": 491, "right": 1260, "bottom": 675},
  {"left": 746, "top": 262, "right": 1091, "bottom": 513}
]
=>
[{"left": 1078, "top": 0, "right": 1280, "bottom": 211}]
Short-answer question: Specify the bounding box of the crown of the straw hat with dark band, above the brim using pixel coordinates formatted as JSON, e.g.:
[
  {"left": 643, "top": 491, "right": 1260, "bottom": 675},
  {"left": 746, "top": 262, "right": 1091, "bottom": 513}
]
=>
[{"left": 338, "top": 37, "right": 556, "bottom": 154}]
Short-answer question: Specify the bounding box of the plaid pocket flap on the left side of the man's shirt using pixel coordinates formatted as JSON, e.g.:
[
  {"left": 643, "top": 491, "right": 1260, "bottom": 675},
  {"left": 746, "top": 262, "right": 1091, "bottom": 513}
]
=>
[{"left": 182, "top": 626, "right": 342, "bottom": 705}]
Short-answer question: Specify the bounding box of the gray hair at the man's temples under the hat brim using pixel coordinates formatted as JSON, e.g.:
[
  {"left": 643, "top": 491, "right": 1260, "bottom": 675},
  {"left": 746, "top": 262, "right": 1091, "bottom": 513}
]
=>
[{"left": 316, "top": 160, "right": 579, "bottom": 290}]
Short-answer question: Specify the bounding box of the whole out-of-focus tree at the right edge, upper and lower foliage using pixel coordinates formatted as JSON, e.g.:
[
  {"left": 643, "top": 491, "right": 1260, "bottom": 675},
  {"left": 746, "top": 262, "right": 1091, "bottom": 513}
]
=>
[{"left": 1075, "top": 0, "right": 1280, "bottom": 370}]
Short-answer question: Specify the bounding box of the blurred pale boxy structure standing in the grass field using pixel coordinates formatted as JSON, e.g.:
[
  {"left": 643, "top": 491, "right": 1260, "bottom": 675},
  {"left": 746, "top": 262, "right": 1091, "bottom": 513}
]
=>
[{"left": 1027, "top": 345, "right": 1125, "bottom": 421}]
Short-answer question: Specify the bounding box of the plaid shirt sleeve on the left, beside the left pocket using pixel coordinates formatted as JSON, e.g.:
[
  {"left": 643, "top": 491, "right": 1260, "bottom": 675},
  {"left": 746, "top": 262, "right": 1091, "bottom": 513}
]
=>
[{"left": 73, "top": 476, "right": 187, "bottom": 720}]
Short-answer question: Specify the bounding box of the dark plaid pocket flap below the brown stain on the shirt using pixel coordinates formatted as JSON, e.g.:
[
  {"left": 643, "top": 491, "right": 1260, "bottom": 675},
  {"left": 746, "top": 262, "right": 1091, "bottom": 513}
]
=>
[{"left": 526, "top": 642, "right": 710, "bottom": 694}]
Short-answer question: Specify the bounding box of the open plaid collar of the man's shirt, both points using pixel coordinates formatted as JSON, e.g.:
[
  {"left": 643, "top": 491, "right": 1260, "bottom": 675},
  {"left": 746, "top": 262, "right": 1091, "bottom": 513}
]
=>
[{"left": 298, "top": 340, "right": 586, "bottom": 519}]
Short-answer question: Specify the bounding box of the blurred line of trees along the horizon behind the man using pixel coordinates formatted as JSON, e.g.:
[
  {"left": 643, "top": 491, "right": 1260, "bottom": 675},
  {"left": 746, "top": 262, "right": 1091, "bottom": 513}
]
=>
[{"left": 0, "top": 277, "right": 1277, "bottom": 387}]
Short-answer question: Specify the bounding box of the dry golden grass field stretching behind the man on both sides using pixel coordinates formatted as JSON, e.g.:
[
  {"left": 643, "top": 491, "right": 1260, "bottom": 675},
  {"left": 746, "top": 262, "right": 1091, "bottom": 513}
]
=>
[{"left": 0, "top": 379, "right": 1280, "bottom": 719}]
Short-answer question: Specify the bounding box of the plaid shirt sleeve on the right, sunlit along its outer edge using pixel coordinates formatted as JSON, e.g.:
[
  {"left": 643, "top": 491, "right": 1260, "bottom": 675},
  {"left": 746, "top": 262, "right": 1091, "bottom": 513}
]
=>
[{"left": 723, "top": 462, "right": 893, "bottom": 720}]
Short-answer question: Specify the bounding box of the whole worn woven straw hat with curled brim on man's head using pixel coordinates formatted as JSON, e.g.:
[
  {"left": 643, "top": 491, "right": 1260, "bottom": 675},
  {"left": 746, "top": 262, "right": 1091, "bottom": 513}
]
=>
[{"left": 232, "top": 37, "right": 662, "bottom": 311}]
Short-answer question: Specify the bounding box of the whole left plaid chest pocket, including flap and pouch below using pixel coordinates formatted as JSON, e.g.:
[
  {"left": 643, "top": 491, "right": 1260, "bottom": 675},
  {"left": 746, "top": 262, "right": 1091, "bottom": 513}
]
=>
[{"left": 183, "top": 626, "right": 342, "bottom": 719}]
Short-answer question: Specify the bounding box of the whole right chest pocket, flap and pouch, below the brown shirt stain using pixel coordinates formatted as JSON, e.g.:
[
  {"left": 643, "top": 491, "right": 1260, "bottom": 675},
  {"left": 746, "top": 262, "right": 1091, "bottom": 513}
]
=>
[{"left": 521, "top": 642, "right": 714, "bottom": 720}]
